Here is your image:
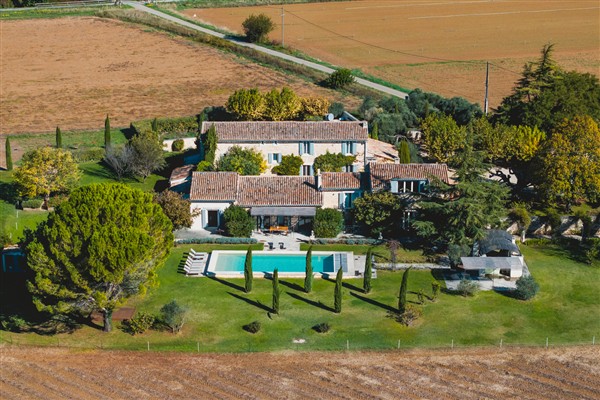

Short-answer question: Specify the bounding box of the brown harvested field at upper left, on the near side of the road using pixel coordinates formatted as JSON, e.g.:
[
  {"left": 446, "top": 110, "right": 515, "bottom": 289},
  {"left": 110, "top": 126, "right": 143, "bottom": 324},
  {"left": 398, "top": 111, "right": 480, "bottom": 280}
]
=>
[{"left": 0, "top": 17, "right": 357, "bottom": 133}]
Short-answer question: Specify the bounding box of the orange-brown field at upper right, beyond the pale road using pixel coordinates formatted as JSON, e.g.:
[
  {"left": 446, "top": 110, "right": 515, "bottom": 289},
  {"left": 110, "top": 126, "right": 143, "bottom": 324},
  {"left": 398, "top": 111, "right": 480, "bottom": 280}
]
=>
[{"left": 185, "top": 0, "right": 600, "bottom": 106}]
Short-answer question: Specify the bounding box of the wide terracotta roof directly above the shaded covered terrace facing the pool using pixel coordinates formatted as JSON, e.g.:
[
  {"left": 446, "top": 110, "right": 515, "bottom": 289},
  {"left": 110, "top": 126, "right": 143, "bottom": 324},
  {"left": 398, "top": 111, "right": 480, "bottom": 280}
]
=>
[{"left": 237, "top": 176, "right": 323, "bottom": 207}]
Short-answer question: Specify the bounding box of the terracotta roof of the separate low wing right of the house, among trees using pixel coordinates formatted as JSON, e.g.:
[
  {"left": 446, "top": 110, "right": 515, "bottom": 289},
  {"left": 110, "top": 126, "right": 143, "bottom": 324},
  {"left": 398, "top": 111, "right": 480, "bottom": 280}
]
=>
[{"left": 369, "top": 163, "right": 450, "bottom": 190}]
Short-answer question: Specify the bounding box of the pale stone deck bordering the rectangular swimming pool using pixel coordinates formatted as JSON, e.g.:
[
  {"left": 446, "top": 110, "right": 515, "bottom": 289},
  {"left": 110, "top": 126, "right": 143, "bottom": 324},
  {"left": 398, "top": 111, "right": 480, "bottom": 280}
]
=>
[{"left": 204, "top": 247, "right": 365, "bottom": 279}]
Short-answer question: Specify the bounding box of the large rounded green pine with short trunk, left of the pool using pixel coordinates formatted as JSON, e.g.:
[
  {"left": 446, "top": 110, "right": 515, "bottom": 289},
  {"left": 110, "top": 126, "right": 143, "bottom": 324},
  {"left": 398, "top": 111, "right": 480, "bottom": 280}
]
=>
[{"left": 22, "top": 184, "right": 173, "bottom": 331}]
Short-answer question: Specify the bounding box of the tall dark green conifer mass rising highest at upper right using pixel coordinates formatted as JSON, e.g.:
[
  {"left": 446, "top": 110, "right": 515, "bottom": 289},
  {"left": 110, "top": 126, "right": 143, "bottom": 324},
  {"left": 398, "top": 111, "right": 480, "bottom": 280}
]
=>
[{"left": 493, "top": 44, "right": 600, "bottom": 133}]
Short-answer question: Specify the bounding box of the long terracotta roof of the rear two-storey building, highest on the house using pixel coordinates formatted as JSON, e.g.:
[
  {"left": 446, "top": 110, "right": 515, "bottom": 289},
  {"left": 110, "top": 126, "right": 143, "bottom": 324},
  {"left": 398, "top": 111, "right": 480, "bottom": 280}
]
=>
[{"left": 202, "top": 121, "right": 369, "bottom": 143}]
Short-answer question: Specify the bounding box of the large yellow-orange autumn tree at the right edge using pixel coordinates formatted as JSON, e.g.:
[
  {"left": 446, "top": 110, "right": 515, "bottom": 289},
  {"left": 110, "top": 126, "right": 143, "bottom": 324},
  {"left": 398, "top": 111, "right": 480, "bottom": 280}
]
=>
[{"left": 539, "top": 116, "right": 600, "bottom": 208}]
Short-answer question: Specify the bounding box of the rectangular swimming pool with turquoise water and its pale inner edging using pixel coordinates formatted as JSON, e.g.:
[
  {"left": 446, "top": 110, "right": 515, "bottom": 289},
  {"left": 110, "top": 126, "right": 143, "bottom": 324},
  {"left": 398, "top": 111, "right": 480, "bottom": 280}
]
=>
[{"left": 205, "top": 250, "right": 354, "bottom": 276}]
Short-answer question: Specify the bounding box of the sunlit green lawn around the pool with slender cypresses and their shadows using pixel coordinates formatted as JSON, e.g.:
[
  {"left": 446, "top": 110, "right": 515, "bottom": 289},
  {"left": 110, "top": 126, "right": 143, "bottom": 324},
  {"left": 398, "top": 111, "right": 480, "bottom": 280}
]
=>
[{"left": 4, "top": 245, "right": 600, "bottom": 352}]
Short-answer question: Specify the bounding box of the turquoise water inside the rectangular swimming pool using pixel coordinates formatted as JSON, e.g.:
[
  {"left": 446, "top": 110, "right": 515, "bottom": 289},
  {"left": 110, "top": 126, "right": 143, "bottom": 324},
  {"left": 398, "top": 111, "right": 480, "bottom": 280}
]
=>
[{"left": 210, "top": 252, "right": 334, "bottom": 273}]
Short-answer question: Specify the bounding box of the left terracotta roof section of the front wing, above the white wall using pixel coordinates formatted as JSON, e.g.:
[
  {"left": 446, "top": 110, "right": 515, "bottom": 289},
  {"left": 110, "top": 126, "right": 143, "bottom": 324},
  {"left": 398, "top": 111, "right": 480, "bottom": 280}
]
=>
[{"left": 190, "top": 172, "right": 238, "bottom": 201}]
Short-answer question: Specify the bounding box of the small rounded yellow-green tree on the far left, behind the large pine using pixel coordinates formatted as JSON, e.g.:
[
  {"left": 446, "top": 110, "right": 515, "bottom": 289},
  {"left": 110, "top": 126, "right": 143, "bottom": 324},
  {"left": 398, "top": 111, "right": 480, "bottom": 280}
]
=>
[{"left": 14, "top": 147, "right": 80, "bottom": 200}]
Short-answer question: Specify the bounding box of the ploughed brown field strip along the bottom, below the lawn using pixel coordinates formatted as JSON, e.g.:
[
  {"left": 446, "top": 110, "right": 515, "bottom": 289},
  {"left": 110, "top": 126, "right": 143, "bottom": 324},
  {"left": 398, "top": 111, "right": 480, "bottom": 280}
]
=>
[{"left": 0, "top": 346, "right": 600, "bottom": 400}]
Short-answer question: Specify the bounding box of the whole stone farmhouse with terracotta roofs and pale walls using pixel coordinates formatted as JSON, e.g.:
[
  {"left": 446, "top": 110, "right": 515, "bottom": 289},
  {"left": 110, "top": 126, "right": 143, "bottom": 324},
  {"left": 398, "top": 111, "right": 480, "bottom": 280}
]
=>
[{"left": 170, "top": 121, "right": 449, "bottom": 232}]
